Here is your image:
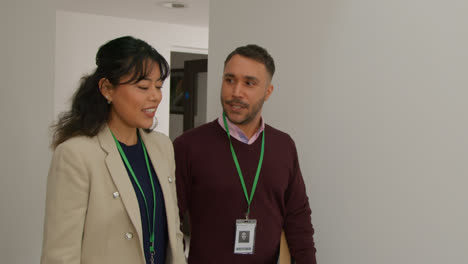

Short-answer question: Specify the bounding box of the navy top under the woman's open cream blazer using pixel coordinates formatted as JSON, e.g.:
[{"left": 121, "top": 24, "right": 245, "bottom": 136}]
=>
[{"left": 119, "top": 138, "right": 168, "bottom": 264}]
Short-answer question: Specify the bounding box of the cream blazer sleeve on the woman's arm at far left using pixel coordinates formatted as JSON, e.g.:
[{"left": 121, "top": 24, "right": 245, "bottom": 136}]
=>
[{"left": 41, "top": 142, "right": 89, "bottom": 264}]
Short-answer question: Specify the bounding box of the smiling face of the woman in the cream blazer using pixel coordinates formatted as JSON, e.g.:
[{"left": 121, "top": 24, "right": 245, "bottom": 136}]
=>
[{"left": 107, "top": 62, "right": 163, "bottom": 132}]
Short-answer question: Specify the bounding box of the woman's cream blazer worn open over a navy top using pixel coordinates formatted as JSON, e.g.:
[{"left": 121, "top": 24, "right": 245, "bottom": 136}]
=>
[{"left": 41, "top": 126, "right": 186, "bottom": 264}]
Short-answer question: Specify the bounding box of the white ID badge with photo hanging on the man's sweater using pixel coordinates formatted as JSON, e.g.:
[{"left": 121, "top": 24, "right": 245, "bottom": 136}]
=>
[{"left": 234, "top": 219, "right": 257, "bottom": 254}]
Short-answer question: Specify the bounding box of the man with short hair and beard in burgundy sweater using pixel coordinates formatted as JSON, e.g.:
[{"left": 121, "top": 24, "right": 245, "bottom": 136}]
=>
[{"left": 174, "top": 45, "right": 316, "bottom": 264}]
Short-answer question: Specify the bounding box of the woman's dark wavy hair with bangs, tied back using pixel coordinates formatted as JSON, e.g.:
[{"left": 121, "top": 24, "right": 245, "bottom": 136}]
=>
[{"left": 52, "top": 36, "right": 170, "bottom": 149}]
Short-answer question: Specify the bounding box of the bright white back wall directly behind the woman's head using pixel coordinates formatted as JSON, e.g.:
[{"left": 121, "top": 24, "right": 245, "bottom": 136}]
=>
[{"left": 54, "top": 11, "right": 208, "bottom": 135}]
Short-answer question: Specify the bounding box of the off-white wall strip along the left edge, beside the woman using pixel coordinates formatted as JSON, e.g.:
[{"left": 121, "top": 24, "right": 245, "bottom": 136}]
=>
[{"left": 0, "top": 0, "right": 55, "bottom": 264}]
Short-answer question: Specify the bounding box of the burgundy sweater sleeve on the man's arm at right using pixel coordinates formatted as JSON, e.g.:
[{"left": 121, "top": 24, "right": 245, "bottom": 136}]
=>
[{"left": 284, "top": 138, "right": 317, "bottom": 264}]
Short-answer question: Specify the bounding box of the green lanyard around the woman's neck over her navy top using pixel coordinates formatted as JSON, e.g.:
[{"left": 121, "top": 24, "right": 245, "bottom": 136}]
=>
[{"left": 111, "top": 131, "right": 156, "bottom": 255}]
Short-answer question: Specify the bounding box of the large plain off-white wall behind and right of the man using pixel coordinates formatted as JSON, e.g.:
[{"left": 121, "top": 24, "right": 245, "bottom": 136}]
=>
[{"left": 208, "top": 0, "right": 468, "bottom": 264}]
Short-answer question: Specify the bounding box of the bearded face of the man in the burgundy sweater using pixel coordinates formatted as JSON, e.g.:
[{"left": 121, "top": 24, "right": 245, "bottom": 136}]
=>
[{"left": 221, "top": 55, "right": 273, "bottom": 128}]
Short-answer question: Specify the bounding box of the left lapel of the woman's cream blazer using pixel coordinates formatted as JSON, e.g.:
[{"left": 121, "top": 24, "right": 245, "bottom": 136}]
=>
[{"left": 98, "top": 125, "right": 144, "bottom": 256}]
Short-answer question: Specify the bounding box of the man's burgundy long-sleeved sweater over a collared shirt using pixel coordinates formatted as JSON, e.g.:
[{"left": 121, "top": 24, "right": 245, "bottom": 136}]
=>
[{"left": 174, "top": 120, "right": 316, "bottom": 264}]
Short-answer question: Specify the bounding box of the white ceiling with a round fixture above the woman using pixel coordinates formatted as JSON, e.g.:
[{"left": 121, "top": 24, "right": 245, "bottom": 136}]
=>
[{"left": 56, "top": 0, "right": 210, "bottom": 28}]
